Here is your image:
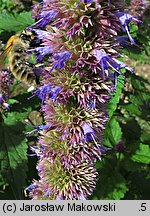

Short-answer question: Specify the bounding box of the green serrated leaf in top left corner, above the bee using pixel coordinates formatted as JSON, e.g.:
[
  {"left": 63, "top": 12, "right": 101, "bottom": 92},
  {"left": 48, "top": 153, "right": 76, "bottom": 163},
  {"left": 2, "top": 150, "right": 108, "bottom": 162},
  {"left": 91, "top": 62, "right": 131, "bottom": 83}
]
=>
[{"left": 0, "top": 12, "right": 34, "bottom": 33}]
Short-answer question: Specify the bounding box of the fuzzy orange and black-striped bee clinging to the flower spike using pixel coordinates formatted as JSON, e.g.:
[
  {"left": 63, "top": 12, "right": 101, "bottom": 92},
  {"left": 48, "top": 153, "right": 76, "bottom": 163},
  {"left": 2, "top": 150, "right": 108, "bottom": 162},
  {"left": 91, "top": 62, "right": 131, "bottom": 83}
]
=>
[{"left": 0, "top": 30, "right": 36, "bottom": 84}]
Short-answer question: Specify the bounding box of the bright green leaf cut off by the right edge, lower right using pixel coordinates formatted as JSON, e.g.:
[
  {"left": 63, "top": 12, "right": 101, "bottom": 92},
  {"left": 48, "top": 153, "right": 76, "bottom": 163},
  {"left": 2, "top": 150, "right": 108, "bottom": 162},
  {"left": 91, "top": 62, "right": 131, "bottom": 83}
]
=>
[{"left": 131, "top": 143, "right": 150, "bottom": 164}]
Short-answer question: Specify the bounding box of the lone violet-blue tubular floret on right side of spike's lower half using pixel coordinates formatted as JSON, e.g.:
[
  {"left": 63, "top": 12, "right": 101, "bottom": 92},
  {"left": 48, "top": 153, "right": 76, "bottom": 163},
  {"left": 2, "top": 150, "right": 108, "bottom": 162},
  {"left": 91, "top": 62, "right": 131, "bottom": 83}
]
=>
[{"left": 81, "top": 122, "right": 95, "bottom": 142}]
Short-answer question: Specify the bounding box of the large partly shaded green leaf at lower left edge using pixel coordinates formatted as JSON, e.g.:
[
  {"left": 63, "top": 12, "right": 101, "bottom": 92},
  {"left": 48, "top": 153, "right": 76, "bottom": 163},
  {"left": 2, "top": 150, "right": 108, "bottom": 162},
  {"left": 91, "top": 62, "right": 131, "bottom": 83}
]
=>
[{"left": 0, "top": 113, "right": 28, "bottom": 199}]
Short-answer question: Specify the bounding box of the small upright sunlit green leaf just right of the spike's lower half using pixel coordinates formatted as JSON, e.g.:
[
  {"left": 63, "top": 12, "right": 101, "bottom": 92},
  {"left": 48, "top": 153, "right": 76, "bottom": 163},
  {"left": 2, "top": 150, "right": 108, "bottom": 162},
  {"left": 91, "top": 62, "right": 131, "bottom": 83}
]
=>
[{"left": 104, "top": 118, "right": 122, "bottom": 147}]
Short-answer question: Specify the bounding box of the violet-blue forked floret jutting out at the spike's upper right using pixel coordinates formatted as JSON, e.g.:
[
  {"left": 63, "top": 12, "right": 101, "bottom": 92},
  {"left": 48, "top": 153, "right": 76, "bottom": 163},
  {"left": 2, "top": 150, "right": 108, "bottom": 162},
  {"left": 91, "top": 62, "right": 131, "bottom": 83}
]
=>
[{"left": 116, "top": 12, "right": 142, "bottom": 45}]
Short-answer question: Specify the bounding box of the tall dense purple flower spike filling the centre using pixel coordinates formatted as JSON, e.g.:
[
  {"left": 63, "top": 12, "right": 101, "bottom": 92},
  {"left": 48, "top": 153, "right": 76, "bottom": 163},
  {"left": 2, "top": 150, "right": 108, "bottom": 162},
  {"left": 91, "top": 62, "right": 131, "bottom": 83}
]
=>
[{"left": 27, "top": 0, "right": 140, "bottom": 200}]
